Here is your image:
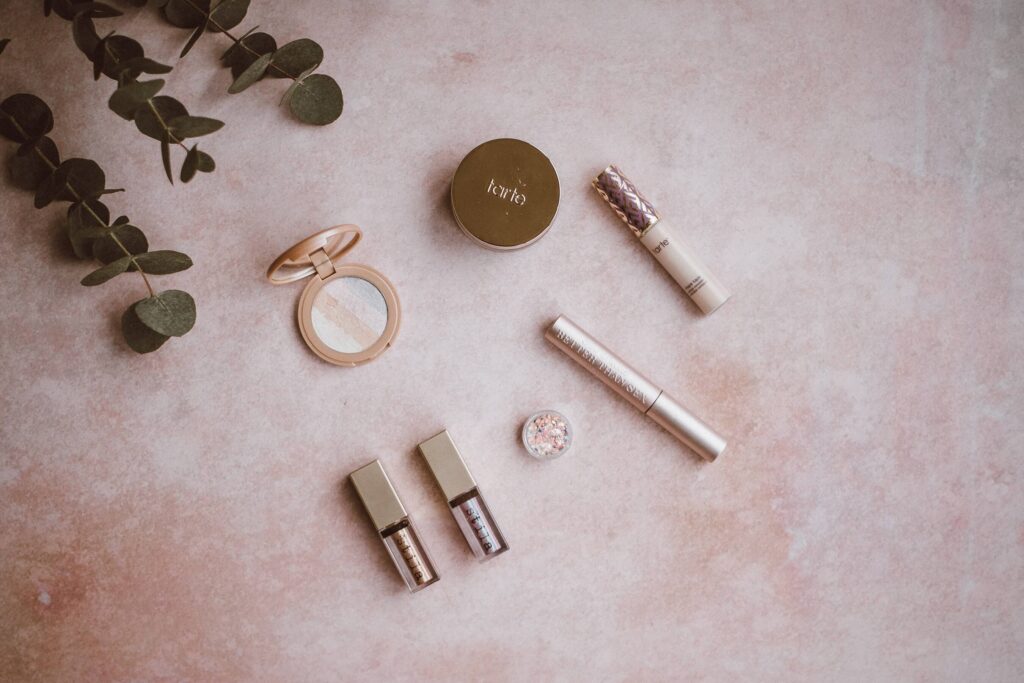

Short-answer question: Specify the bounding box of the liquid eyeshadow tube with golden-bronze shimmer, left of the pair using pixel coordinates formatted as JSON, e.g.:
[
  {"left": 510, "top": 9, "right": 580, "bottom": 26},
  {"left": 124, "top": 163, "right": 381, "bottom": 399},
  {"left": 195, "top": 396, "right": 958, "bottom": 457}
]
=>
[{"left": 348, "top": 460, "right": 440, "bottom": 593}]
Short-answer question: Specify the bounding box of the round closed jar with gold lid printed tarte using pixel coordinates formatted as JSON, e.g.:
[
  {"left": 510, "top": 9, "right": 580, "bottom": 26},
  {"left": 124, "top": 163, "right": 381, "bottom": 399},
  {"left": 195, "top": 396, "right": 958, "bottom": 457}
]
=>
[{"left": 452, "top": 137, "right": 559, "bottom": 250}]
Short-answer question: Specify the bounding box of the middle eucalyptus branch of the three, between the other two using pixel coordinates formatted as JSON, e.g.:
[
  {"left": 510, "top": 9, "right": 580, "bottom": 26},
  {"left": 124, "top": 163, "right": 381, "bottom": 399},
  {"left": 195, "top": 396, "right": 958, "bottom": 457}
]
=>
[{"left": 43, "top": 0, "right": 224, "bottom": 183}]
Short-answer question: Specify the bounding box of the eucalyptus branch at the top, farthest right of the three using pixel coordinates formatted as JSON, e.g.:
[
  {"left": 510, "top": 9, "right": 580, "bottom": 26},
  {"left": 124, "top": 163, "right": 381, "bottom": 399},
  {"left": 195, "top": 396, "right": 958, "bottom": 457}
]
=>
[{"left": 153, "top": 0, "right": 344, "bottom": 126}]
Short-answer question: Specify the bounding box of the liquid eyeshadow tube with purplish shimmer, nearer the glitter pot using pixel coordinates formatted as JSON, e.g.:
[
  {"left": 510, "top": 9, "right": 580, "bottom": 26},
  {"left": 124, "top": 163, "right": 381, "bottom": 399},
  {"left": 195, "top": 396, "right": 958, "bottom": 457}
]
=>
[{"left": 420, "top": 429, "right": 509, "bottom": 562}]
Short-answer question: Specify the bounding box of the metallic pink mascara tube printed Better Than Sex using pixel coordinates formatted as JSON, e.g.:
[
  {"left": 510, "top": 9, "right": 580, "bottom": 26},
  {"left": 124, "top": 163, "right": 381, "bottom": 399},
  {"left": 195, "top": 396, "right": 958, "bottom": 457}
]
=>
[{"left": 544, "top": 315, "right": 725, "bottom": 461}]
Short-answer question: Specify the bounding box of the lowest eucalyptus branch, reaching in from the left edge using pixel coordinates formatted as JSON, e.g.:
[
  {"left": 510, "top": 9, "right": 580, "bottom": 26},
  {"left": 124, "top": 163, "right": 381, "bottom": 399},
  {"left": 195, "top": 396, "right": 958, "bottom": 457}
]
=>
[{"left": 0, "top": 91, "right": 196, "bottom": 353}]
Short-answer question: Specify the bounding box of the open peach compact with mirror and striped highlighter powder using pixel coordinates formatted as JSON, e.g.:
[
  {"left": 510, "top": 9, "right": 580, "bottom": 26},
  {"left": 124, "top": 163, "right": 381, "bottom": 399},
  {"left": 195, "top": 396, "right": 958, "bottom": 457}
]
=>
[{"left": 266, "top": 225, "right": 399, "bottom": 368}]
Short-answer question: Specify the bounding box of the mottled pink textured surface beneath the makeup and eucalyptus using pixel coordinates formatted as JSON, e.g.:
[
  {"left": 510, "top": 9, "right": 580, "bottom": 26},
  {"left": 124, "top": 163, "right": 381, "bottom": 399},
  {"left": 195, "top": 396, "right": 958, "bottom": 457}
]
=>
[{"left": 0, "top": 0, "right": 1024, "bottom": 681}]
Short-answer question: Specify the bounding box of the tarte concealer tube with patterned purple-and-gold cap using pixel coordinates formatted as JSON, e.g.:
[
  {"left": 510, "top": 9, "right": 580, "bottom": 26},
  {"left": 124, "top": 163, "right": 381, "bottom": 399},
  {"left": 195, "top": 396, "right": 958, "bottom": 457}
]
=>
[{"left": 594, "top": 166, "right": 731, "bottom": 314}]
